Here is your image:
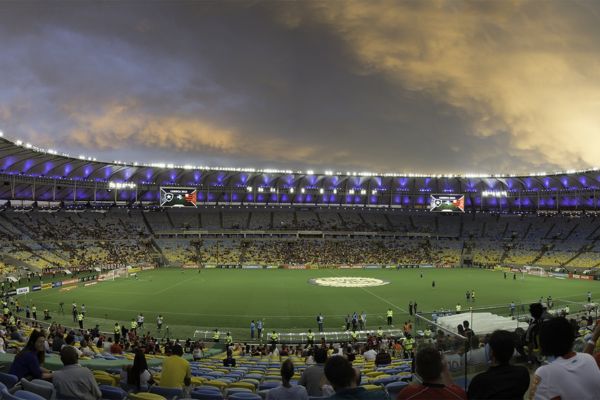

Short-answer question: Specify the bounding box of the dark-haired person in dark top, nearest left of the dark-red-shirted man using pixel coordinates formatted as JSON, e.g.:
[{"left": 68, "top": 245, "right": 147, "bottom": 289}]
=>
[{"left": 324, "top": 357, "right": 386, "bottom": 400}]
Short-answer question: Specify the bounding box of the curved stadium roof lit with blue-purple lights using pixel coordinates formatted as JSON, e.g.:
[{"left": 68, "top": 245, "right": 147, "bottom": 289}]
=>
[{"left": 0, "top": 137, "right": 600, "bottom": 208}]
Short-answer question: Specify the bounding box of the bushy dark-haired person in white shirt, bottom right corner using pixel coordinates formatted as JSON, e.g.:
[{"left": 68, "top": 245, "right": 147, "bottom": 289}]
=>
[{"left": 529, "top": 317, "right": 600, "bottom": 400}]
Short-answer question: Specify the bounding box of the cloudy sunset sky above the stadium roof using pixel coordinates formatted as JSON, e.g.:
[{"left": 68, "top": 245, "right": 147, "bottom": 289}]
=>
[{"left": 0, "top": 0, "right": 600, "bottom": 173}]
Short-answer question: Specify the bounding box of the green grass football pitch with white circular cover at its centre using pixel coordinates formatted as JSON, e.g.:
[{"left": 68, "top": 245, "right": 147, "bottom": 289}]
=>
[{"left": 19, "top": 269, "right": 600, "bottom": 340}]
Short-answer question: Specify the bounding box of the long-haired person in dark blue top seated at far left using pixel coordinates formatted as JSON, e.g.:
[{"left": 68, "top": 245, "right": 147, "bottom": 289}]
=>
[{"left": 9, "top": 329, "right": 52, "bottom": 380}]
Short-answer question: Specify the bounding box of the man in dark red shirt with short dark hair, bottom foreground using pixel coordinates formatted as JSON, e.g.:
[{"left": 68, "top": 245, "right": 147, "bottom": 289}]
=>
[{"left": 397, "top": 347, "right": 467, "bottom": 400}]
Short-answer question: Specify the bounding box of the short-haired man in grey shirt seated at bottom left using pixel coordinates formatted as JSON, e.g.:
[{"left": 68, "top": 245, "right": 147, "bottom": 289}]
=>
[{"left": 52, "top": 346, "right": 102, "bottom": 400}]
